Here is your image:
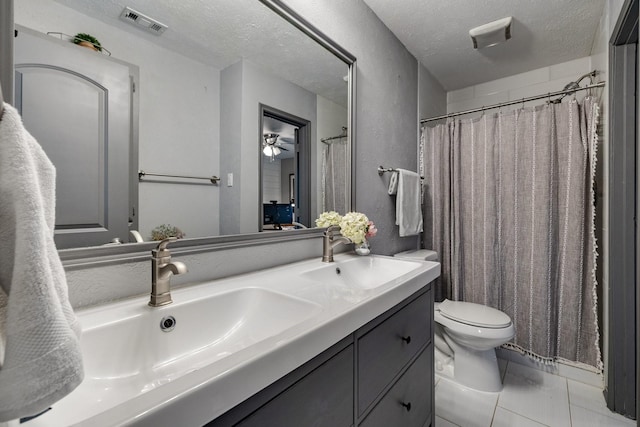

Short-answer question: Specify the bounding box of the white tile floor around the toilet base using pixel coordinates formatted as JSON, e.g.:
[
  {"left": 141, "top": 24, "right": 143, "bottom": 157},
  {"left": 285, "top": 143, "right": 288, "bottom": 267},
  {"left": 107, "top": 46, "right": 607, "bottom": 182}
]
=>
[{"left": 436, "top": 360, "right": 636, "bottom": 427}]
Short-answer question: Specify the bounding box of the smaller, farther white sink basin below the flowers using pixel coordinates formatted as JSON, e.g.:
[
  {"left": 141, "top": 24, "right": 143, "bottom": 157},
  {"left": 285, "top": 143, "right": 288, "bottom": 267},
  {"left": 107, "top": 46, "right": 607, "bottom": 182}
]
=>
[{"left": 302, "top": 256, "right": 422, "bottom": 289}]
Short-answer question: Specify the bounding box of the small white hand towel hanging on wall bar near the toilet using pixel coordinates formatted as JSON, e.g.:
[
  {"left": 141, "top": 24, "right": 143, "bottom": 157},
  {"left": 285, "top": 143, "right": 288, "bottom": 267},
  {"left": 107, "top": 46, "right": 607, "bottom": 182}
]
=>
[{"left": 396, "top": 169, "right": 422, "bottom": 237}]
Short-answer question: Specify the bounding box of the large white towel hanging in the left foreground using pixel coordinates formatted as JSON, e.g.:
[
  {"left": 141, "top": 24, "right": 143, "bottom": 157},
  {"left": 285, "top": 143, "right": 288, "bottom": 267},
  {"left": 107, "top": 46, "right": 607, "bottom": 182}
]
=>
[{"left": 0, "top": 104, "right": 84, "bottom": 421}]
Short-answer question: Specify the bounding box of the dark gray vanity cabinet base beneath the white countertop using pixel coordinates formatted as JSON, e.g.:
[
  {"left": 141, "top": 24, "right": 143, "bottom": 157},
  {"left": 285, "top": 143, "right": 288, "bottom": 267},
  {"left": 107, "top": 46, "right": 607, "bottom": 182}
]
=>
[{"left": 207, "top": 285, "right": 434, "bottom": 427}]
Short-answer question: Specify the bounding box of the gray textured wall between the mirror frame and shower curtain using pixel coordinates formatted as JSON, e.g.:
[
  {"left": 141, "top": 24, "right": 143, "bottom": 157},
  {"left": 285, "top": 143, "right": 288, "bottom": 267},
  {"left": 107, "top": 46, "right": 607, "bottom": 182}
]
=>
[{"left": 286, "top": 0, "right": 446, "bottom": 255}]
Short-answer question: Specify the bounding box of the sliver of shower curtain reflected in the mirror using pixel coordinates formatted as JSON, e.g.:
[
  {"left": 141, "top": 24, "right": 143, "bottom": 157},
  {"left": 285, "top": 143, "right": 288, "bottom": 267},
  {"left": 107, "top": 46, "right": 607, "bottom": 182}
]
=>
[{"left": 322, "top": 137, "right": 349, "bottom": 215}]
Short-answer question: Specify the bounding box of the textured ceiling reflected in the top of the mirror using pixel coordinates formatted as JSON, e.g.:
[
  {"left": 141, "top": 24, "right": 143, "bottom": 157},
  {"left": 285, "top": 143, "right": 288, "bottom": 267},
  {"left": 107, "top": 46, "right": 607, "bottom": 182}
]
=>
[{"left": 56, "top": 0, "right": 347, "bottom": 106}]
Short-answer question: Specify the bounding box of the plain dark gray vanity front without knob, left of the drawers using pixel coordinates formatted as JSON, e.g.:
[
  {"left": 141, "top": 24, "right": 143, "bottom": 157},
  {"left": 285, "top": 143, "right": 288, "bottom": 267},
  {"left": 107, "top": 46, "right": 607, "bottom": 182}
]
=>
[{"left": 236, "top": 344, "right": 353, "bottom": 427}]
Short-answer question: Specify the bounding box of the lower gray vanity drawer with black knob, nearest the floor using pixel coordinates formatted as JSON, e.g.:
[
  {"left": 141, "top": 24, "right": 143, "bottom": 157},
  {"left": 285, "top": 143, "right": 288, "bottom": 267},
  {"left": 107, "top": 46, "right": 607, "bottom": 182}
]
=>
[{"left": 360, "top": 346, "right": 433, "bottom": 427}]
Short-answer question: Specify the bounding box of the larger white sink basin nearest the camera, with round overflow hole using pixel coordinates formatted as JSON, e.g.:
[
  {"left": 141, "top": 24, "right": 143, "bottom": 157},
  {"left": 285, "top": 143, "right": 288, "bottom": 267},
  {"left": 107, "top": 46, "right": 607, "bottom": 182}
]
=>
[{"left": 72, "top": 287, "right": 321, "bottom": 418}]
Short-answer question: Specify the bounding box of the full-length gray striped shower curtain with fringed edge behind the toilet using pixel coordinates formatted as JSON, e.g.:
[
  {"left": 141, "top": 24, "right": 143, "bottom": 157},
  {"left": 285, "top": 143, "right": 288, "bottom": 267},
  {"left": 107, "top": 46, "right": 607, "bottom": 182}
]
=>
[{"left": 421, "top": 98, "right": 601, "bottom": 369}]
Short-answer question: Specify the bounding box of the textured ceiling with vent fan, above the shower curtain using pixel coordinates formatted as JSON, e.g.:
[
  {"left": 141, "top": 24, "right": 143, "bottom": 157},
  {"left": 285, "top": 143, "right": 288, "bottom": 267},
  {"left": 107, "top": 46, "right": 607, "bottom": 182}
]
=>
[{"left": 364, "top": 0, "right": 605, "bottom": 91}]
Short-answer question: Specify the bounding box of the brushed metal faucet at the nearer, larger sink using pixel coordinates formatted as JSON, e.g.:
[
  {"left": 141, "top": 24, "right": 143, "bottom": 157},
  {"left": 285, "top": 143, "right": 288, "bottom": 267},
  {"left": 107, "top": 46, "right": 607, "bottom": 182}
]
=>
[{"left": 149, "top": 237, "right": 187, "bottom": 307}]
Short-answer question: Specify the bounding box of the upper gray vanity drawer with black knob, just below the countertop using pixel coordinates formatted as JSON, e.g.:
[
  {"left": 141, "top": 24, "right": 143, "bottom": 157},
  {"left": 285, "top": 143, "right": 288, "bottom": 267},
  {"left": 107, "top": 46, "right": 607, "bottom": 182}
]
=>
[{"left": 358, "top": 290, "right": 433, "bottom": 415}]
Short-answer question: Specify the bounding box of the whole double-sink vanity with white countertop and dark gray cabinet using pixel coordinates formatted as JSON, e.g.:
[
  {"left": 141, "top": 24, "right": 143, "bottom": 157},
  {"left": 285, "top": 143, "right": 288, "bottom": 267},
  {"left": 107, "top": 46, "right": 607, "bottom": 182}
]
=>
[{"left": 25, "top": 254, "right": 440, "bottom": 427}]
